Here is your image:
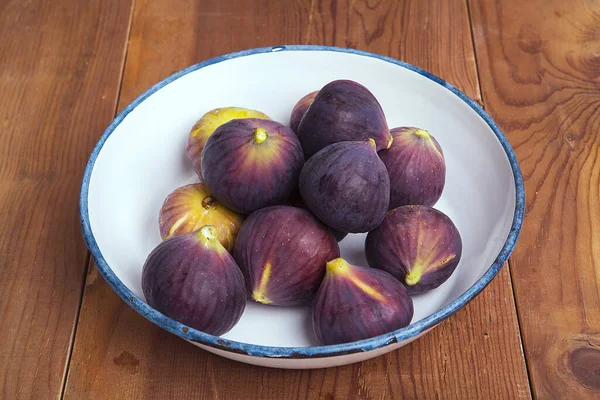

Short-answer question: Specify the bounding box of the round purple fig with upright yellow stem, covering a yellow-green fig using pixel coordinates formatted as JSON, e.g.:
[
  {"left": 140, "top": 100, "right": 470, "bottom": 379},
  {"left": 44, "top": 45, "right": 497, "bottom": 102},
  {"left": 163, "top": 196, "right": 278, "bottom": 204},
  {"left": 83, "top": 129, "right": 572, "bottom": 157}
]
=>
[{"left": 202, "top": 118, "right": 304, "bottom": 214}]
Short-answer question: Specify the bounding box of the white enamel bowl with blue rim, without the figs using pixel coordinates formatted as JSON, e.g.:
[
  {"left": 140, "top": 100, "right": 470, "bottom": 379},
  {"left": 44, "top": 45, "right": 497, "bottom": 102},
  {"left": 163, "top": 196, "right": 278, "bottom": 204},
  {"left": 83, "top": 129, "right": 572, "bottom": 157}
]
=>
[{"left": 80, "top": 46, "right": 524, "bottom": 368}]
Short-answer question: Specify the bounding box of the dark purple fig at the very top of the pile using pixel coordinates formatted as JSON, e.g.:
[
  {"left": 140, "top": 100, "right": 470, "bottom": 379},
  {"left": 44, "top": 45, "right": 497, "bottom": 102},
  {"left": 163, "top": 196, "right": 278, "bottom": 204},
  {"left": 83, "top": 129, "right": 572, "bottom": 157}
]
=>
[{"left": 298, "top": 80, "right": 393, "bottom": 160}]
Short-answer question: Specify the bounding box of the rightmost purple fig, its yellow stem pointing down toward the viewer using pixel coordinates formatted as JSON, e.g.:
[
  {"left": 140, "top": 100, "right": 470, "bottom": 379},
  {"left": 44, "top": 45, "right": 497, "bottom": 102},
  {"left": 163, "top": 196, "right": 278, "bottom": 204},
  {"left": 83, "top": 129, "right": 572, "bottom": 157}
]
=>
[{"left": 365, "top": 205, "right": 462, "bottom": 294}]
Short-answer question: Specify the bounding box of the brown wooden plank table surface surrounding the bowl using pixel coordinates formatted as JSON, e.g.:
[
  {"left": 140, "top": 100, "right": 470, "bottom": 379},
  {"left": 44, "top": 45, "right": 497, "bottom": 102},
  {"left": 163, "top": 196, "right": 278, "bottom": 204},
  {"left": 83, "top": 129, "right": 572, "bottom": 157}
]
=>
[{"left": 0, "top": 0, "right": 600, "bottom": 400}]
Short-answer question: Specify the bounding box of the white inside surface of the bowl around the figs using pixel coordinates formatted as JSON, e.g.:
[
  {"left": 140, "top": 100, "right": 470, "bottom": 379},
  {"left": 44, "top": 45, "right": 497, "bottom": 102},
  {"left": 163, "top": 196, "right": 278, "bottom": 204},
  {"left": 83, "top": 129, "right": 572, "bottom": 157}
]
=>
[{"left": 88, "top": 50, "right": 515, "bottom": 347}]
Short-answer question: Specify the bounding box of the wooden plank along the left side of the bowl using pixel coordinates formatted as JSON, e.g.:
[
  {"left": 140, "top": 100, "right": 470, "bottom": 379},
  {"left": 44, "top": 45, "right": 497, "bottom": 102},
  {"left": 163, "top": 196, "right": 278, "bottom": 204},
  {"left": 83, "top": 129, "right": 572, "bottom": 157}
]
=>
[{"left": 0, "top": 0, "right": 131, "bottom": 399}]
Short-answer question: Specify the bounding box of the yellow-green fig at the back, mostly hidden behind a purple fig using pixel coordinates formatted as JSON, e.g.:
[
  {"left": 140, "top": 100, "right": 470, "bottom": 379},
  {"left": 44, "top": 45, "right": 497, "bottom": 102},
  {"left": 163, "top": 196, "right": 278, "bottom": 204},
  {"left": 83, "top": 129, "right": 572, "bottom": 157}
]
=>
[{"left": 185, "top": 107, "right": 271, "bottom": 179}]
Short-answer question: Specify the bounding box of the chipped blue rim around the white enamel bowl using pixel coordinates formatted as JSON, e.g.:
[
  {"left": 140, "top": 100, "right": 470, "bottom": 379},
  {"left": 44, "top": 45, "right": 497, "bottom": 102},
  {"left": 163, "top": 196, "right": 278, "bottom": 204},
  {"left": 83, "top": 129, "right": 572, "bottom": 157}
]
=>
[{"left": 79, "top": 45, "right": 525, "bottom": 359}]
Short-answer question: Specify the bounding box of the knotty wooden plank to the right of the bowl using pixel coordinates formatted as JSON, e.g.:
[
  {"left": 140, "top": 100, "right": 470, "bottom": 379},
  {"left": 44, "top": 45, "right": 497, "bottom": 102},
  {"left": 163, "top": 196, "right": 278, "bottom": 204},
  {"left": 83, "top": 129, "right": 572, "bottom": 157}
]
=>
[{"left": 470, "top": 0, "right": 600, "bottom": 399}]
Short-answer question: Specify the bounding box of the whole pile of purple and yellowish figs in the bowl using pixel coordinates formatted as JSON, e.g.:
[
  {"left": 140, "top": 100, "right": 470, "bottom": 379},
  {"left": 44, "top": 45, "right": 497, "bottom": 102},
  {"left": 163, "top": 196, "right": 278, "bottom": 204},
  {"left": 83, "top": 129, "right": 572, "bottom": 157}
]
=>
[{"left": 142, "top": 80, "right": 462, "bottom": 345}]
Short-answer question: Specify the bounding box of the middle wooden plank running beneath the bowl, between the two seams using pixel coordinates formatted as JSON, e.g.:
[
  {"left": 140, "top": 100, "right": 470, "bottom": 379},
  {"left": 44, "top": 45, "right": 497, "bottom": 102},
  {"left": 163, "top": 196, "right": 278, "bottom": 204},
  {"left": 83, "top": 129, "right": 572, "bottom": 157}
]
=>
[{"left": 65, "top": 0, "right": 530, "bottom": 399}]
